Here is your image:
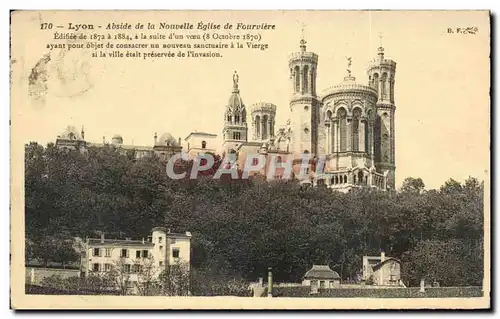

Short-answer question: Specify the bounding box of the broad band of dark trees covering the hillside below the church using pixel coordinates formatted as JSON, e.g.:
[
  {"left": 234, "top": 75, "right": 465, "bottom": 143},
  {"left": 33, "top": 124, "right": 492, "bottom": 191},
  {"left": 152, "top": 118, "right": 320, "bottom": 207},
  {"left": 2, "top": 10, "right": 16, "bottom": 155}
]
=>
[{"left": 25, "top": 143, "right": 484, "bottom": 286}]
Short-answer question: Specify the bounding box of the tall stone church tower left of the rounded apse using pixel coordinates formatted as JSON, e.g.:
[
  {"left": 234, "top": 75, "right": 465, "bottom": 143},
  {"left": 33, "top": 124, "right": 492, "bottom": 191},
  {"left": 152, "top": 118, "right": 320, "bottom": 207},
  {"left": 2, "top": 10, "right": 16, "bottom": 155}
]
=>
[{"left": 288, "top": 39, "right": 320, "bottom": 155}]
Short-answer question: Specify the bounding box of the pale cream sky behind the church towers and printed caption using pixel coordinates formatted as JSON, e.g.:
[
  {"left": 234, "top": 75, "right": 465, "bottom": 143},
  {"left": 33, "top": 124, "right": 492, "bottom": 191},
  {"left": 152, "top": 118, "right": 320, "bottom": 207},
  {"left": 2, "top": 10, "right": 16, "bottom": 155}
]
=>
[{"left": 11, "top": 11, "right": 490, "bottom": 188}]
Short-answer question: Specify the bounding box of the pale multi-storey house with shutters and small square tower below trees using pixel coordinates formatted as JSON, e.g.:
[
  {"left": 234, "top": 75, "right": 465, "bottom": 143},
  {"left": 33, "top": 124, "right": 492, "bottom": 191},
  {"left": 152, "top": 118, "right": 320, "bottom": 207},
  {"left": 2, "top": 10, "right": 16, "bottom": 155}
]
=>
[{"left": 81, "top": 227, "right": 191, "bottom": 293}]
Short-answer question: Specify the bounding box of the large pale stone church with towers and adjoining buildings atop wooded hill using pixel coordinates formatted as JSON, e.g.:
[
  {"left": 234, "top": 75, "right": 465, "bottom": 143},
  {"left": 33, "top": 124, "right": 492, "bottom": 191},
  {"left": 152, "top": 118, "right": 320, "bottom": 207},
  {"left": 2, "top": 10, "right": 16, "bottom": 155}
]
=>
[{"left": 56, "top": 39, "right": 396, "bottom": 191}]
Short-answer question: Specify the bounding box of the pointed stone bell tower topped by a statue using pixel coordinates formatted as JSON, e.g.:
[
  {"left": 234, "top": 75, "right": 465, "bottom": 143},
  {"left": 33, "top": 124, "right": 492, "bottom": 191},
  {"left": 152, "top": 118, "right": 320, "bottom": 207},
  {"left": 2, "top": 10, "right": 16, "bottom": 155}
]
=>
[{"left": 222, "top": 71, "right": 248, "bottom": 151}]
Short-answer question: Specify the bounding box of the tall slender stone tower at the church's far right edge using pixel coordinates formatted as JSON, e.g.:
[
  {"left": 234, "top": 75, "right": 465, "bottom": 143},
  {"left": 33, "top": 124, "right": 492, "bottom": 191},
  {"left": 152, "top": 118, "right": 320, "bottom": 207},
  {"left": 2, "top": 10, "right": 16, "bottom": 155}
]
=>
[{"left": 368, "top": 47, "right": 396, "bottom": 189}]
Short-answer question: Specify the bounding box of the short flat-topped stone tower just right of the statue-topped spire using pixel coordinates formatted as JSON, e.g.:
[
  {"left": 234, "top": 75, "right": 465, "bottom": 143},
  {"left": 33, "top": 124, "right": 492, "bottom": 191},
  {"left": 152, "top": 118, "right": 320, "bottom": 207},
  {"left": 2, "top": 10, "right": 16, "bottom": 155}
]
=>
[{"left": 250, "top": 102, "right": 276, "bottom": 142}]
